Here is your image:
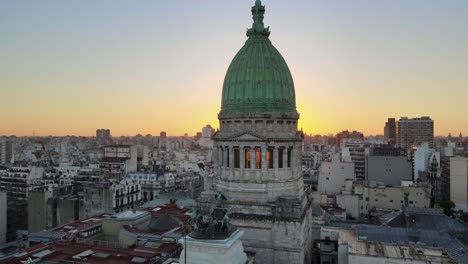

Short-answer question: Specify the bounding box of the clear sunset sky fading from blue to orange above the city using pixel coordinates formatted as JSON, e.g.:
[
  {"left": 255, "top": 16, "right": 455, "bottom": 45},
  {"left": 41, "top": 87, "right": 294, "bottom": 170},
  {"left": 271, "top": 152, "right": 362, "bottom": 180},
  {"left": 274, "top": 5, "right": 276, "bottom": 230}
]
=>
[{"left": 0, "top": 0, "right": 468, "bottom": 136}]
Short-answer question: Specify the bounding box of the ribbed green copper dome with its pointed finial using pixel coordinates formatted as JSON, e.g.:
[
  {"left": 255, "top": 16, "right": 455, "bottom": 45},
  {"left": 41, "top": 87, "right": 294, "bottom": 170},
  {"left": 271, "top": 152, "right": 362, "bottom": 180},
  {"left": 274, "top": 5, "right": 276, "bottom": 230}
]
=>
[{"left": 220, "top": 0, "right": 297, "bottom": 115}]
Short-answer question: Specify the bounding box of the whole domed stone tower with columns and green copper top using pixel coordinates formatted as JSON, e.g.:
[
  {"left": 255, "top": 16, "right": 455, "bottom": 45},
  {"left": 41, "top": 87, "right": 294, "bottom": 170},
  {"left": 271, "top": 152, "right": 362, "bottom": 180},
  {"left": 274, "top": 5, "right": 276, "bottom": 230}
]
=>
[{"left": 199, "top": 0, "right": 312, "bottom": 263}]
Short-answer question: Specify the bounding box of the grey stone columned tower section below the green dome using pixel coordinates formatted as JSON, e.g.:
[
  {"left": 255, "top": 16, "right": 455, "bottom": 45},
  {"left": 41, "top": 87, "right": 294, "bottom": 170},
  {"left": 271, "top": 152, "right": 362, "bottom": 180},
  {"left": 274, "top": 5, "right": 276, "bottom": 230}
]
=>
[{"left": 199, "top": 115, "right": 312, "bottom": 263}]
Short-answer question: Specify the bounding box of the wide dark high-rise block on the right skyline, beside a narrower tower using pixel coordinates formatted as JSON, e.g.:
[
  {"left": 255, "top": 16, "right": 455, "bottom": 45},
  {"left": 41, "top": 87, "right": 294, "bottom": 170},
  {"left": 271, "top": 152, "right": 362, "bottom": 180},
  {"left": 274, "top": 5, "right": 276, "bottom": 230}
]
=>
[{"left": 397, "top": 116, "right": 434, "bottom": 149}]
